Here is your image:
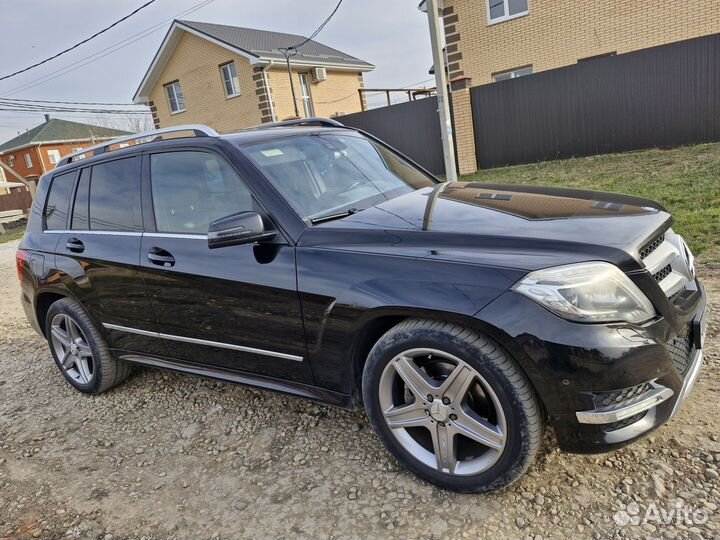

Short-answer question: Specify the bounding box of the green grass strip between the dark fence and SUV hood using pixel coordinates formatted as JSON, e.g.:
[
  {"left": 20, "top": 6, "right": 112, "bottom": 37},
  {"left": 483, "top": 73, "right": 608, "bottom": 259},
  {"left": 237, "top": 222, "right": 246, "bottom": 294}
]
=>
[{"left": 461, "top": 143, "right": 720, "bottom": 258}]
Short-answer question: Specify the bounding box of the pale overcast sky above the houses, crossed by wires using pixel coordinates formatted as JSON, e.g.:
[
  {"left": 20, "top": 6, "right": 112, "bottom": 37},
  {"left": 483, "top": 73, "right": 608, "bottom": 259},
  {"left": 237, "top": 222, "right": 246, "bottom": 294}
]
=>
[{"left": 0, "top": 0, "right": 432, "bottom": 142}]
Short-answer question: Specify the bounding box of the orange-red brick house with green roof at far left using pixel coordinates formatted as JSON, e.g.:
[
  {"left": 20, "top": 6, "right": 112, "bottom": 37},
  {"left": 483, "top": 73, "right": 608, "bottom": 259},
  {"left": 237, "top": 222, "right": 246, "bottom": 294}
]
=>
[{"left": 0, "top": 115, "right": 128, "bottom": 184}]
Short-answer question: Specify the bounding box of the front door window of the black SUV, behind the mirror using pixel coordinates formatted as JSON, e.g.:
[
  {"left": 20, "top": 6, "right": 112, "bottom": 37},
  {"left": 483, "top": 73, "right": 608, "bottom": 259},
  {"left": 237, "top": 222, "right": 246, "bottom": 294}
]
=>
[{"left": 150, "top": 151, "right": 253, "bottom": 234}]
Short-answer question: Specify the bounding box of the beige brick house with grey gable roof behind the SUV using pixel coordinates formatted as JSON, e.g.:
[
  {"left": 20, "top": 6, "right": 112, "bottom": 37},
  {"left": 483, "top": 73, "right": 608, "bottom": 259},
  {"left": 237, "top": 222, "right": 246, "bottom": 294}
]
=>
[{"left": 133, "top": 20, "right": 374, "bottom": 131}]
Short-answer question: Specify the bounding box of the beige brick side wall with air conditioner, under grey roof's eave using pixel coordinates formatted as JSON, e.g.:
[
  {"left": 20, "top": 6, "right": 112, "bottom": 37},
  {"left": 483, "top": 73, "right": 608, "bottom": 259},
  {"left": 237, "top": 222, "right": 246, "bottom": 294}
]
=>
[{"left": 268, "top": 68, "right": 362, "bottom": 120}]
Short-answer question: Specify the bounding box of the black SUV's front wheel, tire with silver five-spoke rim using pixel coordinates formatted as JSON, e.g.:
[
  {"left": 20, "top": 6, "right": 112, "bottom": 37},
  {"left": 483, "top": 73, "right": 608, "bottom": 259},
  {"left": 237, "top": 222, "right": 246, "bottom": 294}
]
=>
[{"left": 362, "top": 319, "right": 544, "bottom": 493}]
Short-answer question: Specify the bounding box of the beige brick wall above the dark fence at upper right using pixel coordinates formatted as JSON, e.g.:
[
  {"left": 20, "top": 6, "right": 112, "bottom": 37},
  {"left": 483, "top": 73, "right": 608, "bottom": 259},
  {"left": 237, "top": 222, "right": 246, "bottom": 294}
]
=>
[{"left": 445, "top": 0, "right": 720, "bottom": 85}]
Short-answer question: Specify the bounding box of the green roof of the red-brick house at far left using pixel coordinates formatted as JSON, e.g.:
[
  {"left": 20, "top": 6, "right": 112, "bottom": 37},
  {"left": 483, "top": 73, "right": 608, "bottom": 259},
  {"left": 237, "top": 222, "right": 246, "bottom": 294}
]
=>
[{"left": 0, "top": 118, "right": 129, "bottom": 154}]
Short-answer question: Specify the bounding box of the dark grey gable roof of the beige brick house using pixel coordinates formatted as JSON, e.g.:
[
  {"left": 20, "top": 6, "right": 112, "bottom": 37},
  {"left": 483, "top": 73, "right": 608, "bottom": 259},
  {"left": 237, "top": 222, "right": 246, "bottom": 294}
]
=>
[{"left": 133, "top": 20, "right": 375, "bottom": 103}]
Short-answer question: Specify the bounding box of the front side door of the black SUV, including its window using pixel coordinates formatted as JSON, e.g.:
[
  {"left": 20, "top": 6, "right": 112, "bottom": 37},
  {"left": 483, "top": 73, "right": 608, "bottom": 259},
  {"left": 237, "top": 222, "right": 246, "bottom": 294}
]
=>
[{"left": 141, "top": 150, "right": 313, "bottom": 383}]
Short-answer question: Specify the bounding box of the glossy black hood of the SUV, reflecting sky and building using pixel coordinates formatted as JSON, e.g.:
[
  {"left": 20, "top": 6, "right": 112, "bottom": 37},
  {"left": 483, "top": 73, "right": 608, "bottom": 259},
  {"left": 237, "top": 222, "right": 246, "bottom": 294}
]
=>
[{"left": 304, "top": 182, "right": 672, "bottom": 271}]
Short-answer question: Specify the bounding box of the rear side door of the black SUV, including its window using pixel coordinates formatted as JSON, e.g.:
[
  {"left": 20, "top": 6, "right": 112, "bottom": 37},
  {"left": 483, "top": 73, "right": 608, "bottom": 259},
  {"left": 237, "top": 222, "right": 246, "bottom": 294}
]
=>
[{"left": 55, "top": 156, "right": 161, "bottom": 353}]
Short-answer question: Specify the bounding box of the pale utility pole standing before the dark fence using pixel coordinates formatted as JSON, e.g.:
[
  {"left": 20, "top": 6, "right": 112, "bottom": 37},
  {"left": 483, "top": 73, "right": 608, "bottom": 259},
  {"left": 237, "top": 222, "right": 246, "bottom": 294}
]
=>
[{"left": 420, "top": 0, "right": 457, "bottom": 182}]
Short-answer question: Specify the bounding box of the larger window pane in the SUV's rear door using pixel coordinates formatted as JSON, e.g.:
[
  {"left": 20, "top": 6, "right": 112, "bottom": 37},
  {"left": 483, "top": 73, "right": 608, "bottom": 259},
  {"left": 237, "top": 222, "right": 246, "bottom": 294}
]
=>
[{"left": 89, "top": 157, "right": 140, "bottom": 231}]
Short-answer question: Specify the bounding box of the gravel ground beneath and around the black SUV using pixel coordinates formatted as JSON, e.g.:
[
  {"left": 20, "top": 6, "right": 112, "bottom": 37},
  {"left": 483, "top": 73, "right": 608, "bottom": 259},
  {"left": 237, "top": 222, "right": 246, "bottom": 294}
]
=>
[{"left": 0, "top": 242, "right": 720, "bottom": 540}]
